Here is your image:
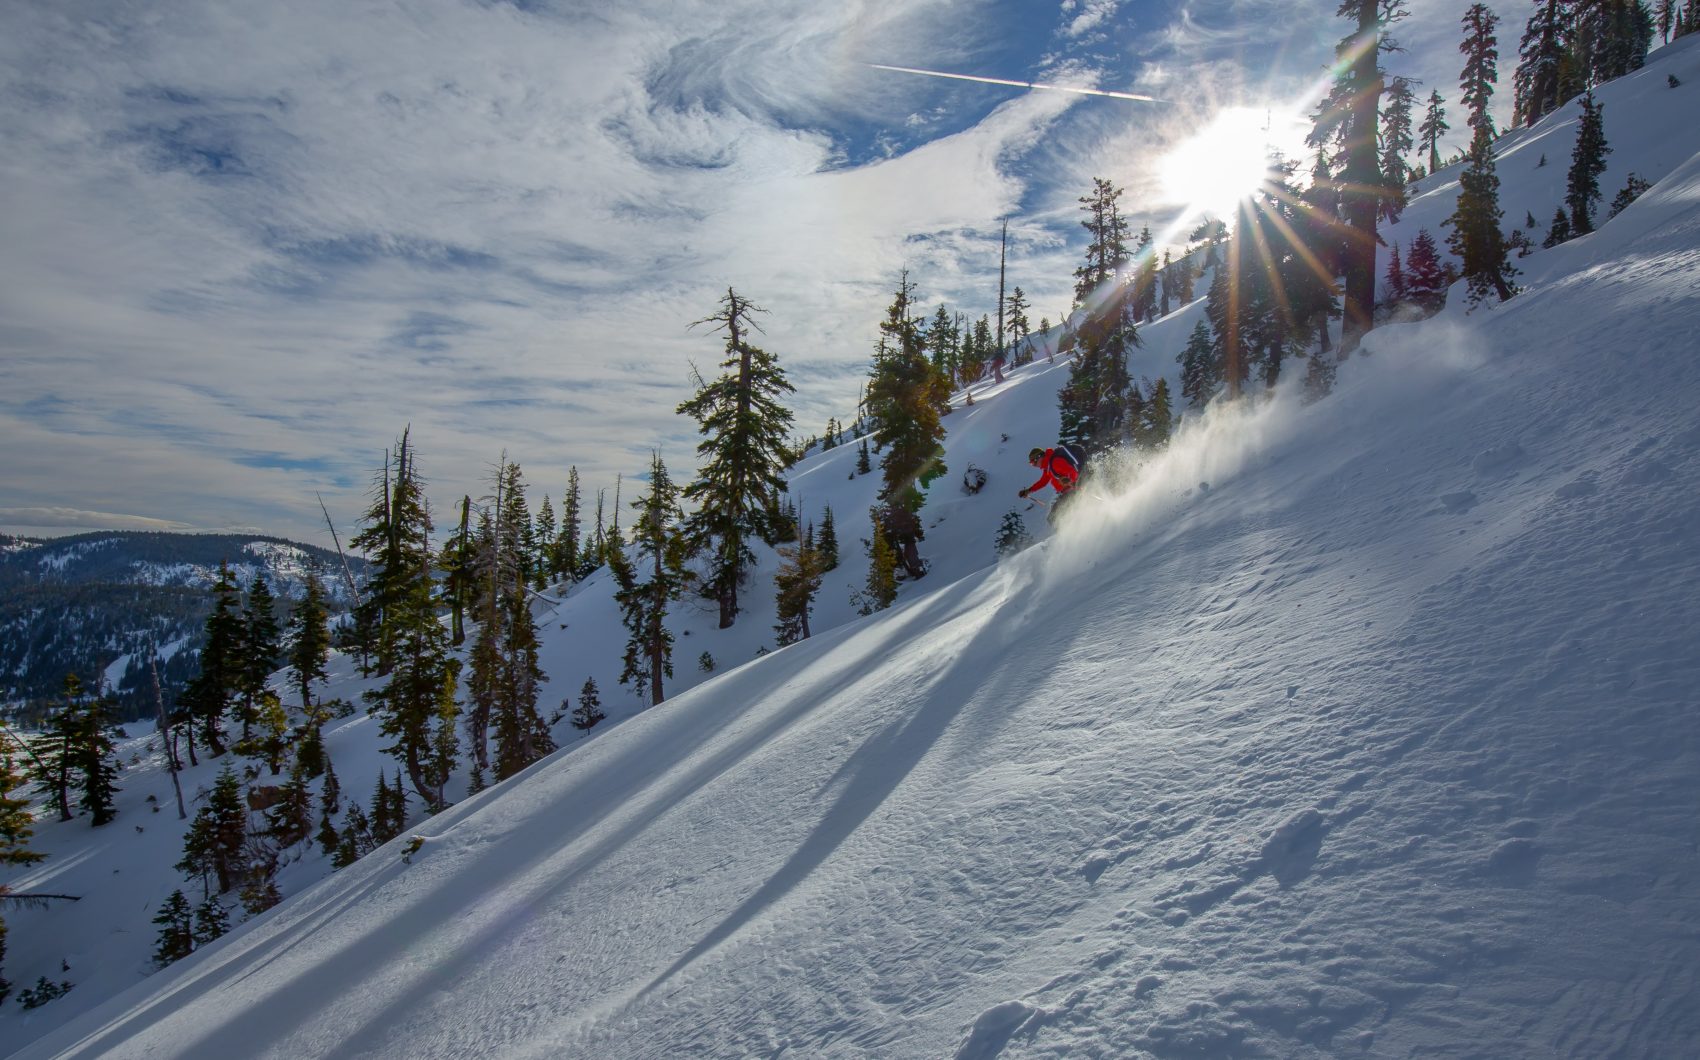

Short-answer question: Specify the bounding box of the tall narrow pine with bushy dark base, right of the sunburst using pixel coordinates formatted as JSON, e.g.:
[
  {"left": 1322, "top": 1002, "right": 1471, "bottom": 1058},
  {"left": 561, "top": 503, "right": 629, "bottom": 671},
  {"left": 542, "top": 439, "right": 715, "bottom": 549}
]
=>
[{"left": 1447, "top": 3, "right": 1516, "bottom": 304}]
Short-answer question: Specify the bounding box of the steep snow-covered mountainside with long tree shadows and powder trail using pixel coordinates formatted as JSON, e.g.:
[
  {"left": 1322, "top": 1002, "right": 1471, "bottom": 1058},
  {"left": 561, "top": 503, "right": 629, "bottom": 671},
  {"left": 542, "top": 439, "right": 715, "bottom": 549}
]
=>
[{"left": 0, "top": 37, "right": 1700, "bottom": 1060}]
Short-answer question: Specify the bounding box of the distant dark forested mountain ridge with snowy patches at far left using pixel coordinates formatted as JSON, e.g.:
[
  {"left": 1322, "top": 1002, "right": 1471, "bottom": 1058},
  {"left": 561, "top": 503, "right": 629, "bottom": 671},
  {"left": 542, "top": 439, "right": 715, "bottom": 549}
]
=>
[{"left": 0, "top": 530, "right": 366, "bottom": 717}]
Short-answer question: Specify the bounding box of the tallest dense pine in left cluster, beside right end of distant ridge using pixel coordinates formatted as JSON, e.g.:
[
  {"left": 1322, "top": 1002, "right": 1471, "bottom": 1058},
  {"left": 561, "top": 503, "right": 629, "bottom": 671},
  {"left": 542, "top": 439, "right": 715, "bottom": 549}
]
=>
[{"left": 355, "top": 433, "right": 459, "bottom": 810}]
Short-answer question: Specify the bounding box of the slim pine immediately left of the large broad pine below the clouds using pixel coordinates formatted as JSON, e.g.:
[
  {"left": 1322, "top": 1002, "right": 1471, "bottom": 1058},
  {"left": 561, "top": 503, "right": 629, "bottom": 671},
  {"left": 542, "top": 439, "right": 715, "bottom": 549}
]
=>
[{"left": 614, "top": 454, "right": 687, "bottom": 707}]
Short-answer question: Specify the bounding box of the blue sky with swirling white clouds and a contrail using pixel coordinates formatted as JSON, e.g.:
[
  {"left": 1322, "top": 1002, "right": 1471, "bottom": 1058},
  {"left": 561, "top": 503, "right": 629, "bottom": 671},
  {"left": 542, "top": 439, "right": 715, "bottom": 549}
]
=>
[{"left": 0, "top": 0, "right": 1489, "bottom": 540}]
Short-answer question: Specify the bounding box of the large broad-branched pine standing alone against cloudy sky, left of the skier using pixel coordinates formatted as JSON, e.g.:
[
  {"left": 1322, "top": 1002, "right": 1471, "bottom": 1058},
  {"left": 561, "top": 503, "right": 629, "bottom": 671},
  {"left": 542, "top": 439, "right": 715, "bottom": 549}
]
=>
[{"left": 678, "top": 287, "right": 796, "bottom": 629}]
